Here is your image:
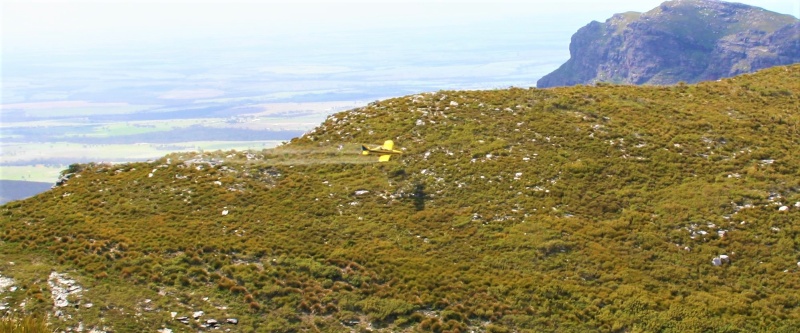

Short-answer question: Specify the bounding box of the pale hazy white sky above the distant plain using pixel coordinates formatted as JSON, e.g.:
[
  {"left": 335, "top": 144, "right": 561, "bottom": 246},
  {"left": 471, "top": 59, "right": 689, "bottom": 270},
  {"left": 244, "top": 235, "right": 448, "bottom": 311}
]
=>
[{"left": 6, "top": 0, "right": 800, "bottom": 55}]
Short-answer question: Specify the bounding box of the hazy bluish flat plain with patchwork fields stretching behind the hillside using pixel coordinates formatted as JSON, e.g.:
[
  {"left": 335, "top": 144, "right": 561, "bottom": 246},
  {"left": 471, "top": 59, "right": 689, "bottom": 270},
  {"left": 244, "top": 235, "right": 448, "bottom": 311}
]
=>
[{"left": 0, "top": 24, "right": 570, "bottom": 187}]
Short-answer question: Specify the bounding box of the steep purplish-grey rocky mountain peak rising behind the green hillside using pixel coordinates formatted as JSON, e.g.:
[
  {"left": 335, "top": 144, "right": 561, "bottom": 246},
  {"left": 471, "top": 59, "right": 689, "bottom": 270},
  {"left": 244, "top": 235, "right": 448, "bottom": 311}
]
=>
[{"left": 537, "top": 0, "right": 800, "bottom": 88}]
